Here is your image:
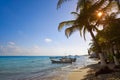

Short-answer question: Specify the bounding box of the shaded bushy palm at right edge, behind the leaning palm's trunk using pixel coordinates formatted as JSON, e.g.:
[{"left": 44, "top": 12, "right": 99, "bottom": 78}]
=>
[{"left": 92, "top": 13, "right": 120, "bottom": 65}]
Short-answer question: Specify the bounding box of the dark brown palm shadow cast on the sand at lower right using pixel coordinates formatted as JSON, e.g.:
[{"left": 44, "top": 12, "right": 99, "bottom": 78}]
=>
[{"left": 82, "top": 64, "right": 120, "bottom": 80}]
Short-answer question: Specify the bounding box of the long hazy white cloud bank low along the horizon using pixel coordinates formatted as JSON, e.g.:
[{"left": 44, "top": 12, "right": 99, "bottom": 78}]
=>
[{"left": 0, "top": 40, "right": 86, "bottom": 56}]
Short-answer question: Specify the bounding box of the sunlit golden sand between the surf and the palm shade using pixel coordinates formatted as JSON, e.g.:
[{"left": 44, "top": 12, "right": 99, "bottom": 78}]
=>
[{"left": 68, "top": 63, "right": 98, "bottom": 80}]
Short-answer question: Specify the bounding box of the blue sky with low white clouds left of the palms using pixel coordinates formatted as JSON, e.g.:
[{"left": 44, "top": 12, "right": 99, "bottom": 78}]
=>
[{"left": 0, "top": 0, "right": 91, "bottom": 56}]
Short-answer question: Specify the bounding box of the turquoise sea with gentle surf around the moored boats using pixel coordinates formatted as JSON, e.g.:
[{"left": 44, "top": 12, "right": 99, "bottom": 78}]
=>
[{"left": 0, "top": 56, "right": 94, "bottom": 80}]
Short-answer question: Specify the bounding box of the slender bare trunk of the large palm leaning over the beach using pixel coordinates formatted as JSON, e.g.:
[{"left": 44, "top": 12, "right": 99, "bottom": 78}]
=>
[{"left": 89, "top": 30, "right": 106, "bottom": 66}]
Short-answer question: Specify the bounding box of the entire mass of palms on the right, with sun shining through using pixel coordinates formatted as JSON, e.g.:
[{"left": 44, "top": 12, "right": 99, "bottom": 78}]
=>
[{"left": 57, "top": 0, "right": 120, "bottom": 66}]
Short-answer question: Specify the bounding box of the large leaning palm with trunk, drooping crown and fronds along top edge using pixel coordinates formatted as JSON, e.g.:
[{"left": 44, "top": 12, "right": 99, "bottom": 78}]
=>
[{"left": 57, "top": 0, "right": 120, "bottom": 65}]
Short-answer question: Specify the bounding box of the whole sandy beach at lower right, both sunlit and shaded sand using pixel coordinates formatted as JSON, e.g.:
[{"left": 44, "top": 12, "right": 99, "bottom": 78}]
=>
[{"left": 68, "top": 64, "right": 120, "bottom": 80}]
